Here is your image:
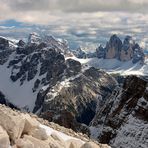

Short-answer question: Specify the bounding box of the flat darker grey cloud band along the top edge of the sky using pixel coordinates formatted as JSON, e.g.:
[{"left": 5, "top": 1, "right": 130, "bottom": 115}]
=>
[{"left": 0, "top": 0, "right": 148, "bottom": 12}]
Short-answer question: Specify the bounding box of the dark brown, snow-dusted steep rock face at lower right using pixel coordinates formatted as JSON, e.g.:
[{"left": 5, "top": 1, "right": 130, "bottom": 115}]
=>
[{"left": 92, "top": 76, "right": 148, "bottom": 148}]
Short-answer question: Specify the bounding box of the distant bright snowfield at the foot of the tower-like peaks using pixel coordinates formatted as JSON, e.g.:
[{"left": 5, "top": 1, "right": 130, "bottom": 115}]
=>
[{"left": 67, "top": 57, "right": 148, "bottom": 76}]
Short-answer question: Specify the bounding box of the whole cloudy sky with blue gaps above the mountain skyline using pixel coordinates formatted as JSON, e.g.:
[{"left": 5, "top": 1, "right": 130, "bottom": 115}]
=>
[{"left": 0, "top": 0, "right": 148, "bottom": 51}]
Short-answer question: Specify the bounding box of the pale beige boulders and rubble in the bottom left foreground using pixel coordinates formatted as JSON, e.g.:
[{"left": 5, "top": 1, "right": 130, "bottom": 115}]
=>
[{"left": 0, "top": 105, "right": 110, "bottom": 148}]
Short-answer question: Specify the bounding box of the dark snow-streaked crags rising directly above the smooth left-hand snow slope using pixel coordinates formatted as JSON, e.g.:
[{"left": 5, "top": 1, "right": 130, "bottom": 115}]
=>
[{"left": 9, "top": 41, "right": 64, "bottom": 85}]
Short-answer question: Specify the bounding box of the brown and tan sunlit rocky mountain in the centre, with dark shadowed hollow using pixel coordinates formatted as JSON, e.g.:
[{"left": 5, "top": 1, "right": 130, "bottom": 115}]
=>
[{"left": 37, "top": 66, "right": 117, "bottom": 130}]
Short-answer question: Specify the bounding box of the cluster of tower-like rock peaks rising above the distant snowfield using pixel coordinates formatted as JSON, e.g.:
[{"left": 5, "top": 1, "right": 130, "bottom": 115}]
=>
[{"left": 96, "top": 35, "right": 144, "bottom": 64}]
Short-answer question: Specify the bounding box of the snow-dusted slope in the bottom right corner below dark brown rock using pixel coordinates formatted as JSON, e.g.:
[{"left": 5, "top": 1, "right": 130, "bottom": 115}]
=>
[{"left": 111, "top": 115, "right": 148, "bottom": 148}]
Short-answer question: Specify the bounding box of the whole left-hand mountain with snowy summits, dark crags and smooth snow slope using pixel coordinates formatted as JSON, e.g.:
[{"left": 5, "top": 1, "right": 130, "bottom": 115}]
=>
[{"left": 0, "top": 33, "right": 71, "bottom": 111}]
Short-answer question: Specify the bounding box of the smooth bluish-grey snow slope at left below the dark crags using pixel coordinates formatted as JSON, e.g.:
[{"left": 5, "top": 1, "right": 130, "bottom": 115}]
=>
[{"left": 0, "top": 54, "right": 37, "bottom": 111}]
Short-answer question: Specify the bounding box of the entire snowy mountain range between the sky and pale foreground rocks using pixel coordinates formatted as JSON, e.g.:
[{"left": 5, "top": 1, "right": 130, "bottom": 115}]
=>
[{"left": 0, "top": 33, "right": 148, "bottom": 148}]
